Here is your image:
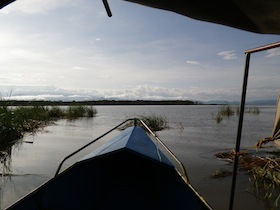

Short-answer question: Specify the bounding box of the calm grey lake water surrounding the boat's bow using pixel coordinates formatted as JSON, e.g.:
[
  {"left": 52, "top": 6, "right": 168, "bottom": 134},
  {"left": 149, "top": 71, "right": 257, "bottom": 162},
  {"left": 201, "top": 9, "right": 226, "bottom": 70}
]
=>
[{"left": 0, "top": 106, "right": 275, "bottom": 210}]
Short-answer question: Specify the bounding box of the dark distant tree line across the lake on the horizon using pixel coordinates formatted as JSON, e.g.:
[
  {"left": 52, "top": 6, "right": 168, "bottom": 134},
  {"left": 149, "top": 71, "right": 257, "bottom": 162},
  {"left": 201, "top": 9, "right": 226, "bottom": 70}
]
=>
[{"left": 0, "top": 100, "right": 201, "bottom": 106}]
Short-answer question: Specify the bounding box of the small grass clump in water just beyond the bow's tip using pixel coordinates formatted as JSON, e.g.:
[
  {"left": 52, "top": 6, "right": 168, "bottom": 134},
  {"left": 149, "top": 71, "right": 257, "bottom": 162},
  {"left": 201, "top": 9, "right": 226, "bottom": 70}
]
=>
[{"left": 120, "top": 113, "right": 168, "bottom": 131}]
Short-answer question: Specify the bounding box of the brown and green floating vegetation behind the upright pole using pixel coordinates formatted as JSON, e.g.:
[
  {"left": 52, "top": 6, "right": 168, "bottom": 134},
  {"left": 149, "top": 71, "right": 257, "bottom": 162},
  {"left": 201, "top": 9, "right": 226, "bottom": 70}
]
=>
[{"left": 215, "top": 150, "right": 280, "bottom": 208}]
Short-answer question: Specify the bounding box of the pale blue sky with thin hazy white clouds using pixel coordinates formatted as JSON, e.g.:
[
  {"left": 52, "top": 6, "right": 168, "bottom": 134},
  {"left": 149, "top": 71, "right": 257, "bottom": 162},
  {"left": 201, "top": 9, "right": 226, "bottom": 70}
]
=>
[{"left": 0, "top": 0, "right": 280, "bottom": 101}]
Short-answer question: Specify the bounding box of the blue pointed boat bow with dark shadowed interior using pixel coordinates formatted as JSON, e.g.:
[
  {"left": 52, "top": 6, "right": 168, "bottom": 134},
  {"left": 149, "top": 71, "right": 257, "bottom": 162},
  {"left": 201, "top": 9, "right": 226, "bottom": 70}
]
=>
[{"left": 8, "top": 120, "right": 211, "bottom": 210}]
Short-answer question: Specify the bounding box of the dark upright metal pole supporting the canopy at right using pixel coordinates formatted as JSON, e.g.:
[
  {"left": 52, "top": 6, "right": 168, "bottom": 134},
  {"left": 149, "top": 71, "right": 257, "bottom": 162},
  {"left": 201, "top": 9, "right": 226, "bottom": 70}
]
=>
[{"left": 229, "top": 53, "right": 251, "bottom": 210}]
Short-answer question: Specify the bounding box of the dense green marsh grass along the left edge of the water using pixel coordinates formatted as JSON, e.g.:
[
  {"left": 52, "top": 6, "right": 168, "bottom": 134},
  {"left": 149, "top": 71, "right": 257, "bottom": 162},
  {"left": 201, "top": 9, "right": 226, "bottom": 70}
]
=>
[{"left": 0, "top": 105, "right": 97, "bottom": 151}]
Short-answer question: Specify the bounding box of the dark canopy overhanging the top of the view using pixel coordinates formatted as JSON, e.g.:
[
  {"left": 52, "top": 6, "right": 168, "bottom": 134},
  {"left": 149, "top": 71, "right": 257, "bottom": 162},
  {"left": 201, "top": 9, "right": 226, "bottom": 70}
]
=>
[{"left": 0, "top": 0, "right": 280, "bottom": 34}]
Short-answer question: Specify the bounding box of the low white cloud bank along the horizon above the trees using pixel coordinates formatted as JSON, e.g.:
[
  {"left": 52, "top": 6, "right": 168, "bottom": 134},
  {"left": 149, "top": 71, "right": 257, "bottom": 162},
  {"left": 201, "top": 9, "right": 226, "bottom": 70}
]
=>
[{"left": 0, "top": 85, "right": 280, "bottom": 101}]
